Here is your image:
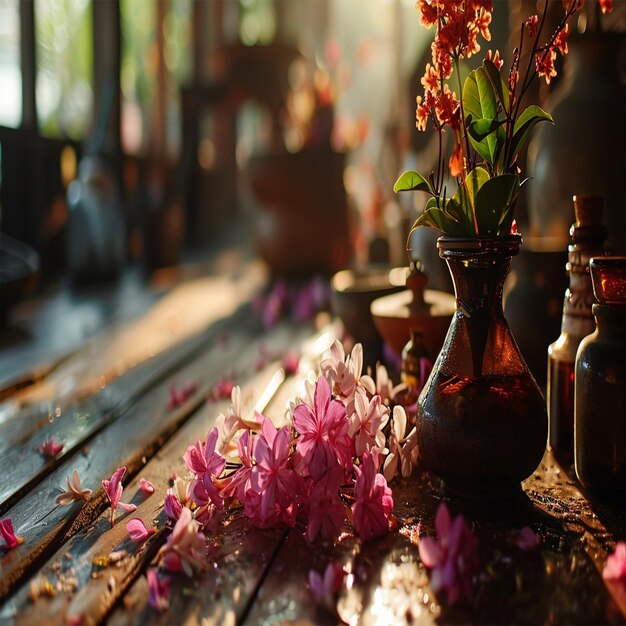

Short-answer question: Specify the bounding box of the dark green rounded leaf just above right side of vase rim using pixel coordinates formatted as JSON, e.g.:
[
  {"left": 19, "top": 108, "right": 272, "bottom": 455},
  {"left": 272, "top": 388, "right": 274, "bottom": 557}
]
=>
[{"left": 474, "top": 174, "right": 519, "bottom": 236}]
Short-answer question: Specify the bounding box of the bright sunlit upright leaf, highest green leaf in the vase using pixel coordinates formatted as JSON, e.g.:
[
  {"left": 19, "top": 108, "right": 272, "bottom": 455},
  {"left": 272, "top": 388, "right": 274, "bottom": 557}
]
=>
[{"left": 463, "top": 67, "right": 498, "bottom": 164}]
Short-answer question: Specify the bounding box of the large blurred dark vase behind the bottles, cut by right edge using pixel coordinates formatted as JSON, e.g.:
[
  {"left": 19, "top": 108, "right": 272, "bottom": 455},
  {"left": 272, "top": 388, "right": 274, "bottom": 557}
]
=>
[{"left": 527, "top": 32, "right": 626, "bottom": 254}]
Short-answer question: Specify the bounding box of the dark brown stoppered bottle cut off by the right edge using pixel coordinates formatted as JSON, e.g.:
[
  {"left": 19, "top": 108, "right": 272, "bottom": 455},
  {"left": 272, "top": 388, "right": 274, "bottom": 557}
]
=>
[{"left": 574, "top": 257, "right": 626, "bottom": 498}]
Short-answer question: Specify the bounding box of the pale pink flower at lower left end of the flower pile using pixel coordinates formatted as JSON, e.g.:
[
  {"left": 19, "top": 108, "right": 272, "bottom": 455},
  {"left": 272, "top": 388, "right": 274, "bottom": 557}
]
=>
[{"left": 159, "top": 507, "right": 208, "bottom": 577}]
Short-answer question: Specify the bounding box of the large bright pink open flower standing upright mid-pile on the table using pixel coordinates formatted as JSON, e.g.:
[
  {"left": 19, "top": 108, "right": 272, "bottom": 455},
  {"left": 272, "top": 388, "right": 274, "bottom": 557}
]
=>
[{"left": 293, "top": 376, "right": 352, "bottom": 480}]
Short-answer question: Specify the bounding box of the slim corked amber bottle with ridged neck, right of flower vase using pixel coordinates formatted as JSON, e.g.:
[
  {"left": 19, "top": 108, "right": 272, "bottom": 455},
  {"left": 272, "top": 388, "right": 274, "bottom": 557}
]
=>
[{"left": 547, "top": 196, "right": 607, "bottom": 466}]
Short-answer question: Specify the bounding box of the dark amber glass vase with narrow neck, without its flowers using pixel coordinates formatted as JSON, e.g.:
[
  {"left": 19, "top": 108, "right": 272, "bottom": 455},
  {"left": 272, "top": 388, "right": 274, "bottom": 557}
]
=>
[{"left": 417, "top": 235, "right": 548, "bottom": 499}]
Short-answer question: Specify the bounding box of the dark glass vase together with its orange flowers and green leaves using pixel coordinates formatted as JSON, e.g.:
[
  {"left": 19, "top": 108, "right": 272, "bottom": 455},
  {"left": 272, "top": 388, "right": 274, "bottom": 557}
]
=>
[{"left": 394, "top": 0, "right": 610, "bottom": 499}]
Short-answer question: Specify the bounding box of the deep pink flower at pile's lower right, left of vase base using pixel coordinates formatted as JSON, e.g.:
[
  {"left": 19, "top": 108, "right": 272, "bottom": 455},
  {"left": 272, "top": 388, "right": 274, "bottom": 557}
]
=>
[{"left": 352, "top": 451, "right": 393, "bottom": 541}]
